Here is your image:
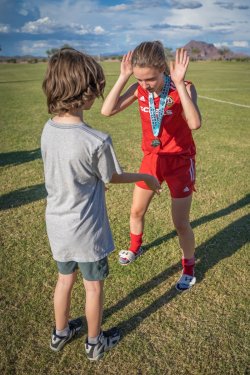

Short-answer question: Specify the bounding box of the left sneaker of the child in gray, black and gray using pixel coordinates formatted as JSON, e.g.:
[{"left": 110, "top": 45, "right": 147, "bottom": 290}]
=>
[{"left": 50, "top": 318, "right": 82, "bottom": 352}]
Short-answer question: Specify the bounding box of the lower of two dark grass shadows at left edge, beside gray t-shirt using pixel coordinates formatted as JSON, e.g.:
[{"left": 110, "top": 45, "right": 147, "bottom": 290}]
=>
[{"left": 0, "top": 184, "right": 47, "bottom": 211}]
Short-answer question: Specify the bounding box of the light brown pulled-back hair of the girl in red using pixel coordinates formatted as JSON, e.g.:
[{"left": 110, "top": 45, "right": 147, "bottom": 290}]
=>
[{"left": 132, "top": 40, "right": 169, "bottom": 75}]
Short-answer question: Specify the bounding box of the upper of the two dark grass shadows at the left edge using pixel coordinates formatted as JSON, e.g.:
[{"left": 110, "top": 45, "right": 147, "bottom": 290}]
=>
[{"left": 0, "top": 148, "right": 41, "bottom": 167}]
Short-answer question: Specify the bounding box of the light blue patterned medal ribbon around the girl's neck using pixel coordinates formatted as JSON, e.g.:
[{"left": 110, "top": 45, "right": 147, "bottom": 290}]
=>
[{"left": 148, "top": 76, "right": 170, "bottom": 137}]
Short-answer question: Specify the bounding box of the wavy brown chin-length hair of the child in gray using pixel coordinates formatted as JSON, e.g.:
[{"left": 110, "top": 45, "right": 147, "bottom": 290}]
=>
[{"left": 42, "top": 48, "right": 105, "bottom": 114}]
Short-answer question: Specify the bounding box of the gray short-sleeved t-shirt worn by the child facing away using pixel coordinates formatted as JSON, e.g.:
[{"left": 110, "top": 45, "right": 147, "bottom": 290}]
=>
[{"left": 41, "top": 120, "right": 122, "bottom": 262}]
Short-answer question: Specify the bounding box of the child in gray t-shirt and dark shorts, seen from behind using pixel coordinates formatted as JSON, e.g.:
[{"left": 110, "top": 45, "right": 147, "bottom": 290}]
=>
[{"left": 41, "top": 48, "right": 160, "bottom": 360}]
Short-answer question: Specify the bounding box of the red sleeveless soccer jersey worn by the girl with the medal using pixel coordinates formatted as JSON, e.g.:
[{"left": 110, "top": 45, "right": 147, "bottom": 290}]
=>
[{"left": 138, "top": 81, "right": 195, "bottom": 157}]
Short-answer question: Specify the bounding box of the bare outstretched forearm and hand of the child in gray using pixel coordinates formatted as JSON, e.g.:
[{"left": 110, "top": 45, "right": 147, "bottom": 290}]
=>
[{"left": 109, "top": 172, "right": 161, "bottom": 194}]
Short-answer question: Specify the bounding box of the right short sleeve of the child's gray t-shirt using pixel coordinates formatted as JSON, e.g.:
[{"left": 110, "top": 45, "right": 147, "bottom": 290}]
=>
[{"left": 93, "top": 137, "right": 122, "bottom": 184}]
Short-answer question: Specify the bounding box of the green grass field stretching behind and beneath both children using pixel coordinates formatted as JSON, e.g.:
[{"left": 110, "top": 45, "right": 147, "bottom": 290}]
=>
[{"left": 0, "top": 62, "right": 250, "bottom": 375}]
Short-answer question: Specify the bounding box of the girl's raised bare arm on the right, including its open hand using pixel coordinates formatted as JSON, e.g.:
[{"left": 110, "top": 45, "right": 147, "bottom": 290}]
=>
[{"left": 170, "top": 48, "right": 201, "bottom": 130}]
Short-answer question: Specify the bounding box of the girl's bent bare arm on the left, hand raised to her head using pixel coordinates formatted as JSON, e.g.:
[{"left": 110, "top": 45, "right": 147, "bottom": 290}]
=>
[{"left": 101, "top": 51, "right": 137, "bottom": 116}]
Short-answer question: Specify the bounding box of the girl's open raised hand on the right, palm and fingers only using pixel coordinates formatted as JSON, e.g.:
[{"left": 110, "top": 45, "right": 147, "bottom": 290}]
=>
[{"left": 170, "top": 48, "right": 189, "bottom": 84}]
